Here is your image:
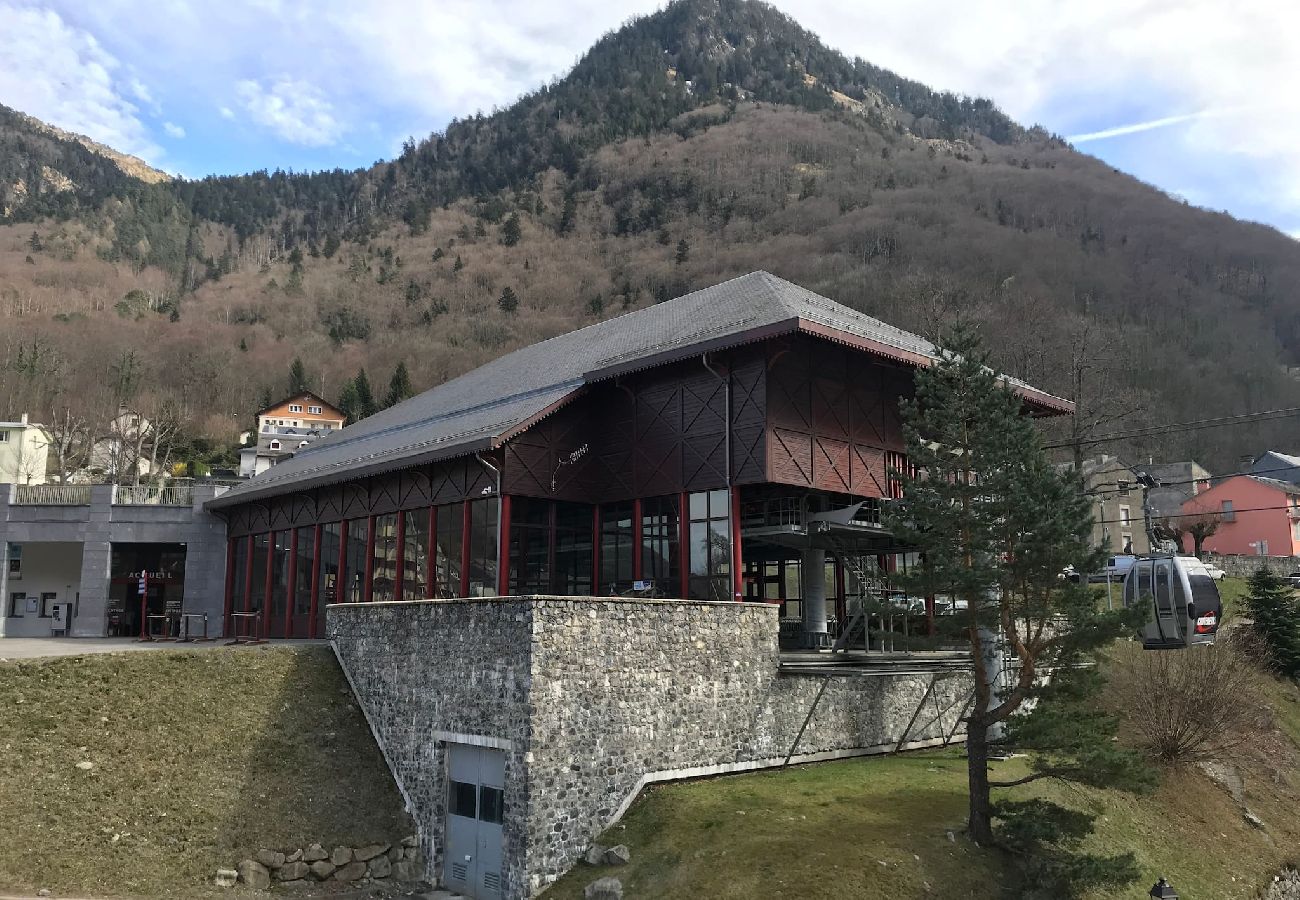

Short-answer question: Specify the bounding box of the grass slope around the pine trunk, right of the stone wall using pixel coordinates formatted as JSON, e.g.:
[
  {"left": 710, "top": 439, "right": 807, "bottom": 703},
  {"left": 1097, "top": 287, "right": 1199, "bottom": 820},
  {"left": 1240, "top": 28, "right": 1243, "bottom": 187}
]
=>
[{"left": 547, "top": 663, "right": 1300, "bottom": 900}]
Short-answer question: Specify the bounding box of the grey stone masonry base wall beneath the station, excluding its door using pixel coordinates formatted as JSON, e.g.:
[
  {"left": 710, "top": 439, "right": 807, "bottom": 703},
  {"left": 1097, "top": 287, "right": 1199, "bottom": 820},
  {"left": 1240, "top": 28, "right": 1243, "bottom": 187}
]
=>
[{"left": 328, "top": 597, "right": 971, "bottom": 897}]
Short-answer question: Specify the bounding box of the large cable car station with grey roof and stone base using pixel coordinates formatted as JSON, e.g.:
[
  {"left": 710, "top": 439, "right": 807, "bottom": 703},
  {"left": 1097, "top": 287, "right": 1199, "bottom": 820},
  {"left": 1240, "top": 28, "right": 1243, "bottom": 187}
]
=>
[{"left": 208, "top": 272, "right": 1071, "bottom": 897}]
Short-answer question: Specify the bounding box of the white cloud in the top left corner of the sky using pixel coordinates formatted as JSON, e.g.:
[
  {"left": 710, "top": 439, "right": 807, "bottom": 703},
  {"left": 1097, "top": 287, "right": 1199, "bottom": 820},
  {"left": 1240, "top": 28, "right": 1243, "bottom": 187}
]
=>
[{"left": 0, "top": 0, "right": 163, "bottom": 160}]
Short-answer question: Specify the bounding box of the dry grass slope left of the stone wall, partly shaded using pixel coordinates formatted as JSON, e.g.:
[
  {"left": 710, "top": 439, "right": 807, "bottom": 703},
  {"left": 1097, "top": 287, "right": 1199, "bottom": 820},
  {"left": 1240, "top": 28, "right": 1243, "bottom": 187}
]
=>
[{"left": 0, "top": 646, "right": 415, "bottom": 897}]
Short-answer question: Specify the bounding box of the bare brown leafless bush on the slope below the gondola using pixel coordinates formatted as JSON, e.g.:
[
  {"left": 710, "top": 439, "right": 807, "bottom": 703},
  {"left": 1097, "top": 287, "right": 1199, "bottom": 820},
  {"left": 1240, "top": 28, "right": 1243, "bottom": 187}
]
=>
[{"left": 1106, "top": 635, "right": 1270, "bottom": 763}]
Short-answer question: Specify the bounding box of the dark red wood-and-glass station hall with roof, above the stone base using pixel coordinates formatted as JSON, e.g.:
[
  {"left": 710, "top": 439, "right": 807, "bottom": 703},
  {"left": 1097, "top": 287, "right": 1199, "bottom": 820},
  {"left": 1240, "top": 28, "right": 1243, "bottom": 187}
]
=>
[{"left": 208, "top": 272, "right": 1071, "bottom": 646}]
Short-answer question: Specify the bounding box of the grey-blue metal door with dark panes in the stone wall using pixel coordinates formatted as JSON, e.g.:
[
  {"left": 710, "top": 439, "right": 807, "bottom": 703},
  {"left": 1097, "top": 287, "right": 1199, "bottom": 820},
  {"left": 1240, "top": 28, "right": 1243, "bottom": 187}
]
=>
[{"left": 442, "top": 744, "right": 506, "bottom": 900}]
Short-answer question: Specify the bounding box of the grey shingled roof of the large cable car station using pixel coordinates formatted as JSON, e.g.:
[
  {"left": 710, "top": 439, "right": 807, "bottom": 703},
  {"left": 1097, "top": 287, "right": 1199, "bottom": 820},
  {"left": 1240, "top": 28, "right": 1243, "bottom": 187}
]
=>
[{"left": 211, "top": 272, "right": 1070, "bottom": 507}]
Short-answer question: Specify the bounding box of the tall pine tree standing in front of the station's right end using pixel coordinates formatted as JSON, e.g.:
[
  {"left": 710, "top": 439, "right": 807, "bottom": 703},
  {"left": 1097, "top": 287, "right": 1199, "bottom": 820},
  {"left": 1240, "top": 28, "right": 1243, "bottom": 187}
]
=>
[{"left": 885, "top": 330, "right": 1152, "bottom": 890}]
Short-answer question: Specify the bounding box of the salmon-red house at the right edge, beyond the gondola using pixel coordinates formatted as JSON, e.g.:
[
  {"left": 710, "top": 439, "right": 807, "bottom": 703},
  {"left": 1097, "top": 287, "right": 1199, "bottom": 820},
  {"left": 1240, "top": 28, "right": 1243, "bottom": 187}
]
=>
[{"left": 1182, "top": 475, "right": 1300, "bottom": 557}]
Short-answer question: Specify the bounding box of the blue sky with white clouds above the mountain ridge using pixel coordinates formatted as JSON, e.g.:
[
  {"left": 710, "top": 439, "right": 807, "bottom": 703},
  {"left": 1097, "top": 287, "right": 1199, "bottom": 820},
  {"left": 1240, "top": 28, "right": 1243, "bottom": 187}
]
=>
[{"left": 0, "top": 0, "right": 1300, "bottom": 237}]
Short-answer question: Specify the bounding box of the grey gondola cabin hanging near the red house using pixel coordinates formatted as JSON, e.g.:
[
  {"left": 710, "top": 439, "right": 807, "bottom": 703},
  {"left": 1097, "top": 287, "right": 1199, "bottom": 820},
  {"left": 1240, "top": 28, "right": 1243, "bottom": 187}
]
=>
[{"left": 1125, "top": 555, "right": 1223, "bottom": 650}]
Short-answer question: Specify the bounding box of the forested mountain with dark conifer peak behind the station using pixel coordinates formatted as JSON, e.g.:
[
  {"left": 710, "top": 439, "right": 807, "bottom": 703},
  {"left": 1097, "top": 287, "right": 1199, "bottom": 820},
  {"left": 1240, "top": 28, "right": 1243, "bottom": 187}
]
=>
[{"left": 0, "top": 0, "right": 1300, "bottom": 478}]
